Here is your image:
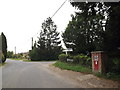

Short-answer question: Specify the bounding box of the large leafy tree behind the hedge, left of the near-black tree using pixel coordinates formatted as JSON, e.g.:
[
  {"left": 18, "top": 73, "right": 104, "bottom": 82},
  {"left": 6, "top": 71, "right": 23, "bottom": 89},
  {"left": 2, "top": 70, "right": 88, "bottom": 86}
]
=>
[{"left": 63, "top": 2, "right": 105, "bottom": 54}]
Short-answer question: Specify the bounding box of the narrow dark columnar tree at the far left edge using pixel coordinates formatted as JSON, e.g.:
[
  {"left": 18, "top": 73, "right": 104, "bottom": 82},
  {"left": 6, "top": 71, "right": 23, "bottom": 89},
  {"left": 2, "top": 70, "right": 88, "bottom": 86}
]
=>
[{"left": 0, "top": 32, "right": 7, "bottom": 63}]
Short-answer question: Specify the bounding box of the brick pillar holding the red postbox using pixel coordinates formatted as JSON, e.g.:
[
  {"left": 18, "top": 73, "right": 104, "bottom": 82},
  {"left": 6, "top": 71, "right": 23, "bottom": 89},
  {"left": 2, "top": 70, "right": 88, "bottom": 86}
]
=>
[{"left": 91, "top": 51, "right": 107, "bottom": 73}]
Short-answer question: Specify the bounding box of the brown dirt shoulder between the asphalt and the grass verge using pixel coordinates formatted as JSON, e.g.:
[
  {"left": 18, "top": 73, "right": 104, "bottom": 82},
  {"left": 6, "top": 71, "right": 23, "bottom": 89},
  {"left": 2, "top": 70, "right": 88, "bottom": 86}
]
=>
[{"left": 49, "top": 64, "right": 120, "bottom": 88}]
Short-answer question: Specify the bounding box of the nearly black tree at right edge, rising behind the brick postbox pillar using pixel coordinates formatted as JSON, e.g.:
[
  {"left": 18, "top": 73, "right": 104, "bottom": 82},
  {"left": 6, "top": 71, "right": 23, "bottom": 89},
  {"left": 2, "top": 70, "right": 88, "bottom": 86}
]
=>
[{"left": 104, "top": 2, "right": 120, "bottom": 57}]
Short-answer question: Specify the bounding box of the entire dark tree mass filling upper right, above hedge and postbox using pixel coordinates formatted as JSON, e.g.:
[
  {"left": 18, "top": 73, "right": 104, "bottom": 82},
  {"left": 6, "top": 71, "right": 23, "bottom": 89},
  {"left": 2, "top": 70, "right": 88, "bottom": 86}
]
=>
[{"left": 63, "top": 2, "right": 120, "bottom": 56}]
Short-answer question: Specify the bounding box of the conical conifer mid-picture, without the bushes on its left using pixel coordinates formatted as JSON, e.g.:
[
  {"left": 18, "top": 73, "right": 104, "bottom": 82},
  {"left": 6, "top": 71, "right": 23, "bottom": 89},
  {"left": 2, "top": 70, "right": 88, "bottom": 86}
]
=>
[{"left": 37, "top": 17, "right": 61, "bottom": 60}]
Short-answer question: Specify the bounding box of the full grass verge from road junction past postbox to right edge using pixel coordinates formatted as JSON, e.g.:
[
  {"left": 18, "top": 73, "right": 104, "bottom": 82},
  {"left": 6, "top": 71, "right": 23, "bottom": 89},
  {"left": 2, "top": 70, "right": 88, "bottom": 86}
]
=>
[{"left": 53, "top": 61, "right": 120, "bottom": 81}]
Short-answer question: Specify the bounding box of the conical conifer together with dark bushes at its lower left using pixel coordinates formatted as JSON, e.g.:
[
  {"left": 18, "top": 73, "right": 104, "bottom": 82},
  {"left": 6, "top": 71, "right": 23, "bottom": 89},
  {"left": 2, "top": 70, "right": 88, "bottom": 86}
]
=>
[{"left": 30, "top": 17, "right": 61, "bottom": 60}]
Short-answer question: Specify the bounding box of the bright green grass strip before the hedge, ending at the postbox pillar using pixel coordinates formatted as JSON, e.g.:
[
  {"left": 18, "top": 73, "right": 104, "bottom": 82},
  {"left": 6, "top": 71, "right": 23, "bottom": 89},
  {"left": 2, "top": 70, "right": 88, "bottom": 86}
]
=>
[{"left": 53, "top": 61, "right": 92, "bottom": 73}]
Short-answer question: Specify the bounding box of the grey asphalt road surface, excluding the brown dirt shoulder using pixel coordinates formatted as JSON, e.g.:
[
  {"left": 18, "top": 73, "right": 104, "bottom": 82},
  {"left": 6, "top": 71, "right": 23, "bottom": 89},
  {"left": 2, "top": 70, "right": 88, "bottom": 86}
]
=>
[{"left": 2, "top": 59, "right": 76, "bottom": 88}]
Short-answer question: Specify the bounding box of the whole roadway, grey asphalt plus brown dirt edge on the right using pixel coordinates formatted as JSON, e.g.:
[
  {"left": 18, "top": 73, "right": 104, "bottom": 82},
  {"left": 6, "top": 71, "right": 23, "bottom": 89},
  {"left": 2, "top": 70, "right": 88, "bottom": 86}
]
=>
[{"left": 2, "top": 59, "right": 120, "bottom": 88}]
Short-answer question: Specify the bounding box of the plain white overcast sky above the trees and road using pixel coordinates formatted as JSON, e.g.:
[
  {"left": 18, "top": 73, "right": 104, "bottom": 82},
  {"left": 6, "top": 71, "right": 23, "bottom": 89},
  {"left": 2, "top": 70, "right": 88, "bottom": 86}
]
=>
[{"left": 0, "top": 0, "right": 75, "bottom": 53}]
